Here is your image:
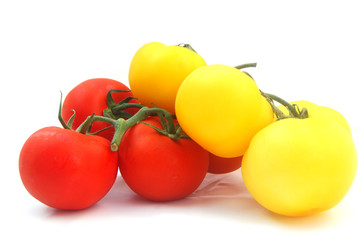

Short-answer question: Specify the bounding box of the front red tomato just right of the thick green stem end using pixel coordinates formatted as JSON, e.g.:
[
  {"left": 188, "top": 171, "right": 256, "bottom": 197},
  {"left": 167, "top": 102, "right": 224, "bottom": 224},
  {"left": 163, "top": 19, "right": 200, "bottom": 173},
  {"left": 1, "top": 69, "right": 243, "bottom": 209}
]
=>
[{"left": 118, "top": 117, "right": 209, "bottom": 201}]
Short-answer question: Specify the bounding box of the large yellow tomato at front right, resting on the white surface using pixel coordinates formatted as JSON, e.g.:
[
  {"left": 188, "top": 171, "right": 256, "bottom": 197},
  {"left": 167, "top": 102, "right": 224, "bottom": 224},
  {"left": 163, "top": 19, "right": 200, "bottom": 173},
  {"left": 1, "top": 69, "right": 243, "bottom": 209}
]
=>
[{"left": 242, "top": 117, "right": 358, "bottom": 216}]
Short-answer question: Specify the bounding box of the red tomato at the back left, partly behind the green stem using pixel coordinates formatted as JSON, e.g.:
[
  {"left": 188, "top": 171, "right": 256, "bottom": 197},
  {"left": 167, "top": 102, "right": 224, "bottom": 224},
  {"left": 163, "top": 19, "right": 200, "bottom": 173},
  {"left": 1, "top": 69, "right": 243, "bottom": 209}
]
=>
[{"left": 62, "top": 78, "right": 138, "bottom": 140}]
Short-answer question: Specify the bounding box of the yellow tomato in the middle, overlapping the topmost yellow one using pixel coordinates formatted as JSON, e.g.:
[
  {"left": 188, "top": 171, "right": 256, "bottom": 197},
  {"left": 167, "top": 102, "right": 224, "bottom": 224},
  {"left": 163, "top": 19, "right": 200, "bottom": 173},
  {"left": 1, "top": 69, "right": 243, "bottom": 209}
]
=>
[{"left": 176, "top": 64, "right": 273, "bottom": 158}]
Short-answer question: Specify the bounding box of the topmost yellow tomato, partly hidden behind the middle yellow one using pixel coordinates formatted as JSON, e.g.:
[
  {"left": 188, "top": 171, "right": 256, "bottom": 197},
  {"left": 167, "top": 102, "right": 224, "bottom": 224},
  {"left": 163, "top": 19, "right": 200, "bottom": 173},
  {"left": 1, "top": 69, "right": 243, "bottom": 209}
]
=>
[{"left": 129, "top": 42, "right": 206, "bottom": 114}]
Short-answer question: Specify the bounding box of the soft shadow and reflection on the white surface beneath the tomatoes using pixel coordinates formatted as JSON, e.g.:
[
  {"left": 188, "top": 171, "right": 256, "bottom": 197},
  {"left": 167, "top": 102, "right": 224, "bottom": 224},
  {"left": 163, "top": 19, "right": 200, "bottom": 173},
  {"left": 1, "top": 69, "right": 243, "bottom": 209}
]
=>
[{"left": 33, "top": 172, "right": 346, "bottom": 229}]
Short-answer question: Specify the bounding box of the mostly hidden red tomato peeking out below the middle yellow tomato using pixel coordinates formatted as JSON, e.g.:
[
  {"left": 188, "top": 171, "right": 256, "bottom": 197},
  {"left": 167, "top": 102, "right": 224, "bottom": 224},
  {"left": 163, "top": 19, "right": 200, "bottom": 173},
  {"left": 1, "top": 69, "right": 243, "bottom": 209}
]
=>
[{"left": 208, "top": 153, "right": 243, "bottom": 174}]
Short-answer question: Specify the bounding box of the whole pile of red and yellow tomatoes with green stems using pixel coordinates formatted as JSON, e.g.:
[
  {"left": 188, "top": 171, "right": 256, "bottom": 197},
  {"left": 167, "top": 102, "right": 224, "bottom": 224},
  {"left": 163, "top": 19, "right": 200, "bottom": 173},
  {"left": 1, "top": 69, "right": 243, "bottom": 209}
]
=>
[{"left": 19, "top": 42, "right": 357, "bottom": 216}]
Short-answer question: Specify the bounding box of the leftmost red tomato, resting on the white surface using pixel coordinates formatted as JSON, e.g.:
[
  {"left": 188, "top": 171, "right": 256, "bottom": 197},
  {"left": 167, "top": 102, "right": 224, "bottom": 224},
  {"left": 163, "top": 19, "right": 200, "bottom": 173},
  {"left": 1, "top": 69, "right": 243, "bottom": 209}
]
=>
[{"left": 19, "top": 127, "right": 118, "bottom": 210}]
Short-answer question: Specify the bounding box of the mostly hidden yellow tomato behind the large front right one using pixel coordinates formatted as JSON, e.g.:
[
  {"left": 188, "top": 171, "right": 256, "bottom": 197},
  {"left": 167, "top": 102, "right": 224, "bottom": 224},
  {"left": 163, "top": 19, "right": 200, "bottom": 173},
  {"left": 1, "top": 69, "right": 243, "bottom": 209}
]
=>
[{"left": 278, "top": 100, "right": 351, "bottom": 133}]
